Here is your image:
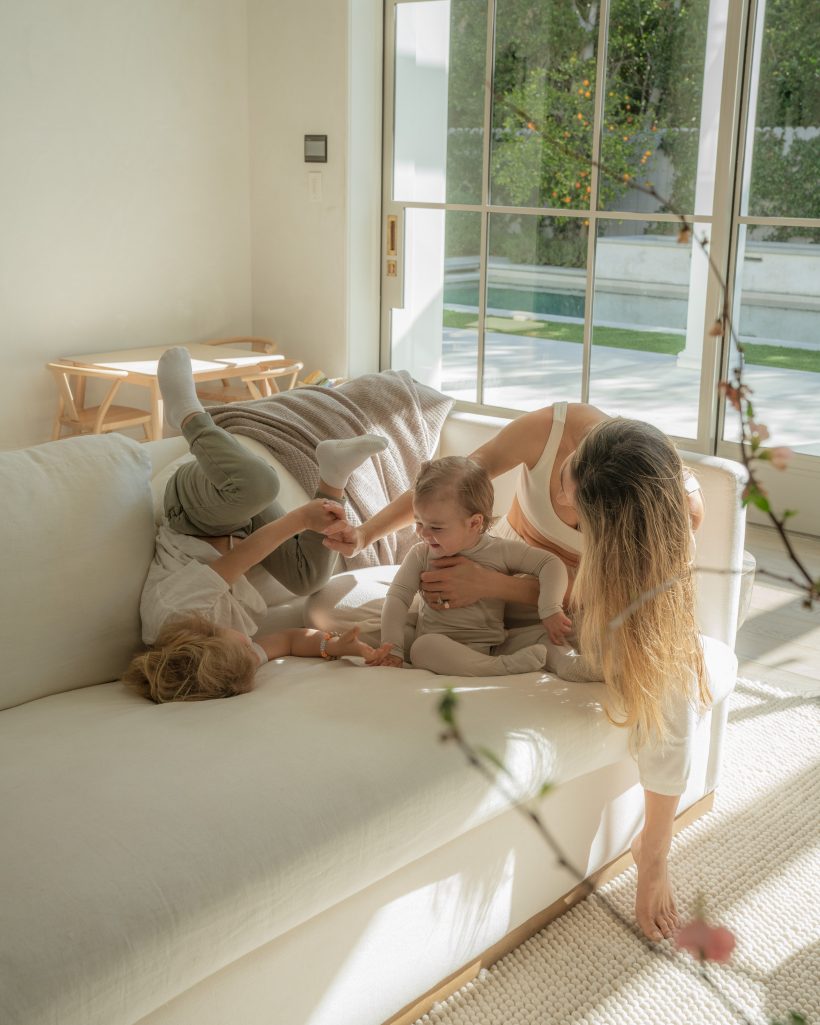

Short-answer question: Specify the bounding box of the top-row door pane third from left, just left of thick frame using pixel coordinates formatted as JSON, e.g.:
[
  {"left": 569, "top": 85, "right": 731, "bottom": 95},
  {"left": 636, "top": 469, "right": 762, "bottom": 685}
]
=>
[{"left": 599, "top": 0, "right": 722, "bottom": 213}]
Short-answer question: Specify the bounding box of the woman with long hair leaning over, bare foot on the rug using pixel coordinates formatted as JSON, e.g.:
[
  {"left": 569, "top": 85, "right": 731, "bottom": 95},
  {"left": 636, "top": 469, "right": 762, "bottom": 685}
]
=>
[{"left": 325, "top": 403, "right": 708, "bottom": 940}]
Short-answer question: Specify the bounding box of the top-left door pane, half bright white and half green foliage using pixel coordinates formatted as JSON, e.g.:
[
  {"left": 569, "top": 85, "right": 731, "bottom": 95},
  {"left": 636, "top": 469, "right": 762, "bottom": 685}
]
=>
[{"left": 394, "top": 0, "right": 487, "bottom": 203}]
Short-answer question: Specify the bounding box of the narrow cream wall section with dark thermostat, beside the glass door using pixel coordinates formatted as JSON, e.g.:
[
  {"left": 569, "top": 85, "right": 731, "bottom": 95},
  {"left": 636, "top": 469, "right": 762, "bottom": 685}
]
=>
[{"left": 248, "top": 0, "right": 381, "bottom": 385}]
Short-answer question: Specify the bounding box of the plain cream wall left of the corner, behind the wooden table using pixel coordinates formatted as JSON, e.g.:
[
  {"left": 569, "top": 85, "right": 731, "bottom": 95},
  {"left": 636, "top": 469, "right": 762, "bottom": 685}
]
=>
[{"left": 0, "top": 0, "right": 251, "bottom": 448}]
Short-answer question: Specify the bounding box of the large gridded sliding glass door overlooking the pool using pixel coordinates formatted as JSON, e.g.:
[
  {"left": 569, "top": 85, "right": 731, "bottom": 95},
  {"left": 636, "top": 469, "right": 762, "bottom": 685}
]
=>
[{"left": 382, "top": 0, "right": 820, "bottom": 528}]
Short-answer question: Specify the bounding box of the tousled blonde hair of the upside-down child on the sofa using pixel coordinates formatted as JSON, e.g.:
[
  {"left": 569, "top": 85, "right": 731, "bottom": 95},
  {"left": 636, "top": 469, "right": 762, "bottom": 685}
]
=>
[{"left": 123, "top": 614, "right": 258, "bottom": 704}]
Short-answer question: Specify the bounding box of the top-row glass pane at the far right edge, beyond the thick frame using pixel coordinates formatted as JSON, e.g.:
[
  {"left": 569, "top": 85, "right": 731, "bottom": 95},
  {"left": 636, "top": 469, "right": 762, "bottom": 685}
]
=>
[{"left": 744, "top": 0, "right": 820, "bottom": 217}]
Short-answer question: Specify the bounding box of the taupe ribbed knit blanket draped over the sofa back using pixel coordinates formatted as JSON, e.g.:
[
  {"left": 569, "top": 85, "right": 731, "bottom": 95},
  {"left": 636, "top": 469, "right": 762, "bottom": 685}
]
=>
[{"left": 208, "top": 370, "right": 453, "bottom": 569}]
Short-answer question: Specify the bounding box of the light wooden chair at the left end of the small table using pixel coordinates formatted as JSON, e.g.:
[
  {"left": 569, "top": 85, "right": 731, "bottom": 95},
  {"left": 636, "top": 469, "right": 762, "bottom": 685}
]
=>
[{"left": 46, "top": 363, "right": 151, "bottom": 441}]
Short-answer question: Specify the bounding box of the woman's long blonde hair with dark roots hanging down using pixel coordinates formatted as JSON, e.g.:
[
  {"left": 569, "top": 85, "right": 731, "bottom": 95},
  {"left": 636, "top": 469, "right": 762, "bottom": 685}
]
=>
[{"left": 570, "top": 418, "right": 710, "bottom": 745}]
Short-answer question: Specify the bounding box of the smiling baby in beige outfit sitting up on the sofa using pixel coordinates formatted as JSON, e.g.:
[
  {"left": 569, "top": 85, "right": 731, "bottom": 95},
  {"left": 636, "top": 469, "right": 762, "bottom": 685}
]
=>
[{"left": 366, "top": 456, "right": 572, "bottom": 677}]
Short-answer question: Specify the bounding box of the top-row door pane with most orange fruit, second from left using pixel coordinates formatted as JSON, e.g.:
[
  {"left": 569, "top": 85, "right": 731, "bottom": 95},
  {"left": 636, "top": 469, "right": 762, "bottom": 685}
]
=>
[{"left": 490, "top": 0, "right": 599, "bottom": 209}]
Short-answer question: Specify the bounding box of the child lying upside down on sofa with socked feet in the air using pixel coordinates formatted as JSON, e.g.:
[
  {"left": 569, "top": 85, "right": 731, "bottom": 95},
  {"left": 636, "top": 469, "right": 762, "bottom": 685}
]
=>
[{"left": 124, "top": 347, "right": 387, "bottom": 703}]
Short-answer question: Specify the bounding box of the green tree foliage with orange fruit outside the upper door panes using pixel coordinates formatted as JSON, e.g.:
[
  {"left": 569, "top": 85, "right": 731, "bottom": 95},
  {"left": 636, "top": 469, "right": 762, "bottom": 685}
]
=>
[{"left": 447, "top": 0, "right": 820, "bottom": 268}]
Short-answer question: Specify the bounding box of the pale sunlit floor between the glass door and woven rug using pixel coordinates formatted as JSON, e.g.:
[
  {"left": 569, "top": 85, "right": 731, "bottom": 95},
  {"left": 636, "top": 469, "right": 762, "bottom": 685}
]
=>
[{"left": 736, "top": 524, "right": 820, "bottom": 695}]
